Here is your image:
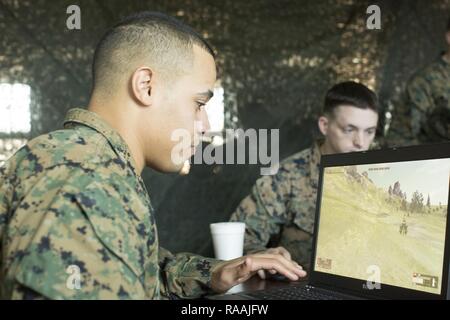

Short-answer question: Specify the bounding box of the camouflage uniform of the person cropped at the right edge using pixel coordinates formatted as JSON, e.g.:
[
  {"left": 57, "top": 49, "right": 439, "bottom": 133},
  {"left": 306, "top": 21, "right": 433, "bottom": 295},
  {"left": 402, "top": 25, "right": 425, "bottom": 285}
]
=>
[{"left": 387, "top": 57, "right": 450, "bottom": 145}]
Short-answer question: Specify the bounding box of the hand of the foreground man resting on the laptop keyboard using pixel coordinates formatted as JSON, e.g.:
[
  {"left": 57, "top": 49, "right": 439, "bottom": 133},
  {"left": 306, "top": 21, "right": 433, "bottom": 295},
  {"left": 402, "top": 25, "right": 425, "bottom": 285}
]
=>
[{"left": 211, "top": 251, "right": 306, "bottom": 293}]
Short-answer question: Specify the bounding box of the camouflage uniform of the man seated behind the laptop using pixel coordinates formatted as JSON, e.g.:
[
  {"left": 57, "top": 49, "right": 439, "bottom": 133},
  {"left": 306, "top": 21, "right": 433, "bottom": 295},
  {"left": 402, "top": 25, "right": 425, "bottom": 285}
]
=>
[{"left": 231, "top": 142, "right": 320, "bottom": 265}]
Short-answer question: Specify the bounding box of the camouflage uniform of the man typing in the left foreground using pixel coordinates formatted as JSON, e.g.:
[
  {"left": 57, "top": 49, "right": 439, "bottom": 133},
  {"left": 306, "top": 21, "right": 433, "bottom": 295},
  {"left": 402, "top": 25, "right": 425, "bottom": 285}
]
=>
[{"left": 0, "top": 109, "right": 218, "bottom": 299}]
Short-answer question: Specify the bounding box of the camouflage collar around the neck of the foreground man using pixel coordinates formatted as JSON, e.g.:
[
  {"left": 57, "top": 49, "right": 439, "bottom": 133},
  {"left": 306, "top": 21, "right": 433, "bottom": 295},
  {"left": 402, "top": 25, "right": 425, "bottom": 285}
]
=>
[{"left": 64, "top": 108, "right": 140, "bottom": 177}]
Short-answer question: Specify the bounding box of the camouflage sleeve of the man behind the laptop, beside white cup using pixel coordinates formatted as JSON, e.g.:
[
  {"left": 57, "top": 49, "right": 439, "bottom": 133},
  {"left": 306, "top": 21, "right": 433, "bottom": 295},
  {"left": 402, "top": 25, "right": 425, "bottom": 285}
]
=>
[{"left": 230, "top": 168, "right": 291, "bottom": 253}]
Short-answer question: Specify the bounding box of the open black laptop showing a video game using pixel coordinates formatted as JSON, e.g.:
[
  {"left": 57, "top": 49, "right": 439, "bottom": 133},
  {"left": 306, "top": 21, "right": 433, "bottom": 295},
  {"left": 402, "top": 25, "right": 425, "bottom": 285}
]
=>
[{"left": 211, "top": 143, "right": 450, "bottom": 300}]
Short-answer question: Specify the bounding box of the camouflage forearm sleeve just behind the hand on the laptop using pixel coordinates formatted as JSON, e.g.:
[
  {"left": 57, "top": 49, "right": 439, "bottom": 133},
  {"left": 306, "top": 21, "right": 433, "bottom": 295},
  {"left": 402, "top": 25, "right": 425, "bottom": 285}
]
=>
[{"left": 159, "top": 247, "right": 222, "bottom": 298}]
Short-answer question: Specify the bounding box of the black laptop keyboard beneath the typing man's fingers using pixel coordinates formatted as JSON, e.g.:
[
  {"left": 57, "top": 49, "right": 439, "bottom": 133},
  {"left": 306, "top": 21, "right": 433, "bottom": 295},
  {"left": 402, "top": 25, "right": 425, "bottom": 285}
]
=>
[{"left": 245, "top": 286, "right": 343, "bottom": 300}]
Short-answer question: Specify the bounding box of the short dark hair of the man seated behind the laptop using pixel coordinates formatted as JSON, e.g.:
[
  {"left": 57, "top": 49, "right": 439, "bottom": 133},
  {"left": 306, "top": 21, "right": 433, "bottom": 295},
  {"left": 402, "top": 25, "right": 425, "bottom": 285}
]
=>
[{"left": 322, "top": 81, "right": 379, "bottom": 116}]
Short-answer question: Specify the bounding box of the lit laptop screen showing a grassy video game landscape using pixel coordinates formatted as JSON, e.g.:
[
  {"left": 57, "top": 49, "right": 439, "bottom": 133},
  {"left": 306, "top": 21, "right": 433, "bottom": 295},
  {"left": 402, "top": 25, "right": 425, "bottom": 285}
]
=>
[{"left": 314, "top": 158, "right": 450, "bottom": 294}]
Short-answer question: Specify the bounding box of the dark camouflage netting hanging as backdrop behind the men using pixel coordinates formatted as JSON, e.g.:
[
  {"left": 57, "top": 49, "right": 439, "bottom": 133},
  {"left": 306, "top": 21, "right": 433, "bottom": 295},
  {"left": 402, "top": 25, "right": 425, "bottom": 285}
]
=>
[{"left": 0, "top": 0, "right": 450, "bottom": 255}]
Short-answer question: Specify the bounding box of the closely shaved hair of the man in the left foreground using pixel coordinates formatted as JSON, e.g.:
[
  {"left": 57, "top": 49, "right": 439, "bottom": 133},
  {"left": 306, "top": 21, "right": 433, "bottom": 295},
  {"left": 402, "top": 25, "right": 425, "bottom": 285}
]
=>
[{"left": 92, "top": 11, "right": 215, "bottom": 90}]
